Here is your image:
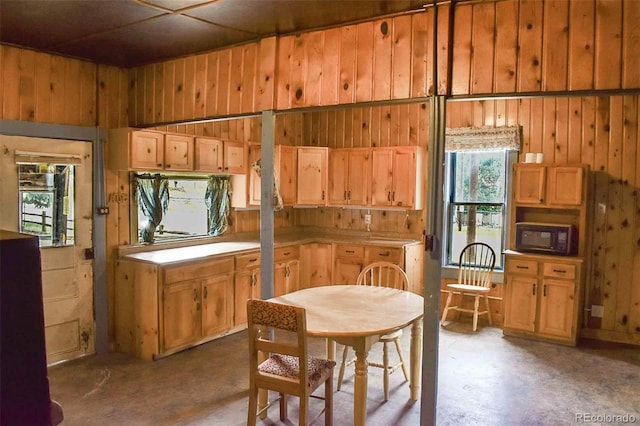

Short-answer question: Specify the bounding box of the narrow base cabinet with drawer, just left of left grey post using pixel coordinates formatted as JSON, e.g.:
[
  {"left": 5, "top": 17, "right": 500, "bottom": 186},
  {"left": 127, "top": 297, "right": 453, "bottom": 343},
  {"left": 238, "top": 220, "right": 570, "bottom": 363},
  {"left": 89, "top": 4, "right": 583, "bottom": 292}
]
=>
[{"left": 233, "top": 252, "right": 262, "bottom": 327}]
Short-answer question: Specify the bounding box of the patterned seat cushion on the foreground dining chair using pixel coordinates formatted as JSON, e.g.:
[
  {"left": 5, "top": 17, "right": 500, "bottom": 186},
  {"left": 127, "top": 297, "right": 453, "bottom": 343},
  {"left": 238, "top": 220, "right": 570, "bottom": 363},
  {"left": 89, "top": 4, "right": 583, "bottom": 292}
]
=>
[{"left": 258, "top": 354, "right": 336, "bottom": 388}]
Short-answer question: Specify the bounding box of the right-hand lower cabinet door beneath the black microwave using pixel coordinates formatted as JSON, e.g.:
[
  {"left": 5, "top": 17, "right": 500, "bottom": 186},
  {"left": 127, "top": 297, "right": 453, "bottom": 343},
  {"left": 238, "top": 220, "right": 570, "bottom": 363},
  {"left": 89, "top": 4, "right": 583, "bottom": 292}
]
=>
[{"left": 538, "top": 278, "right": 575, "bottom": 338}]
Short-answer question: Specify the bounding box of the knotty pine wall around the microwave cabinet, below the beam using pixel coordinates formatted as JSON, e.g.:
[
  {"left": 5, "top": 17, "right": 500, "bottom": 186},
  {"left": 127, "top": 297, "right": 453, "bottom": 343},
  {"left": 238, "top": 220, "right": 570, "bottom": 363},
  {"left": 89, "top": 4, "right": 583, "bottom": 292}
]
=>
[{"left": 447, "top": 95, "right": 640, "bottom": 343}]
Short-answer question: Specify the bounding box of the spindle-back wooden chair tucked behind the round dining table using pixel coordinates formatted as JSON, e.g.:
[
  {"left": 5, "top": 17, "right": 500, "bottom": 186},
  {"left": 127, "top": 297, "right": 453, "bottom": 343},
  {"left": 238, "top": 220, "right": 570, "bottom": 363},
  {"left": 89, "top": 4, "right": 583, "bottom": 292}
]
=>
[{"left": 338, "top": 262, "right": 409, "bottom": 401}]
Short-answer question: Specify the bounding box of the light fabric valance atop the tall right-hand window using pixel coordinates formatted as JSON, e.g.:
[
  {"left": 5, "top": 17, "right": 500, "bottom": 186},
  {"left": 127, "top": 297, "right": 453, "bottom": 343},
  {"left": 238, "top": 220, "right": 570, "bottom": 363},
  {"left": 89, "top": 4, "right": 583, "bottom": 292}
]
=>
[{"left": 445, "top": 126, "right": 521, "bottom": 152}]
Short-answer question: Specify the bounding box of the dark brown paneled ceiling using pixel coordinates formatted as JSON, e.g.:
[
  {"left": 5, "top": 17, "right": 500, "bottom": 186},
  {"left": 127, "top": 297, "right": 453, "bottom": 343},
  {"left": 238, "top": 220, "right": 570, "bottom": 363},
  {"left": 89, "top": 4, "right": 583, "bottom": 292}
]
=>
[{"left": 0, "top": 0, "right": 432, "bottom": 68}]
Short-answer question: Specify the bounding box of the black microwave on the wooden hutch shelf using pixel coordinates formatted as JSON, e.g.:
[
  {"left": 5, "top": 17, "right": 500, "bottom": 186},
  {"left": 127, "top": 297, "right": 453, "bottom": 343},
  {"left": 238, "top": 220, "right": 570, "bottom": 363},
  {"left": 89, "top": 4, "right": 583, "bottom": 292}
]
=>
[{"left": 516, "top": 222, "right": 578, "bottom": 256}]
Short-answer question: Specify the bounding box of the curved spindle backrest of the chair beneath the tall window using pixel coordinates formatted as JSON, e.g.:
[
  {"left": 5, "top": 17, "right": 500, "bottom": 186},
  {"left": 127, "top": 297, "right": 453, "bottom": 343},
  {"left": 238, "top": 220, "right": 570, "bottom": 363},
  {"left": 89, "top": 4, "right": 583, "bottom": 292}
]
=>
[{"left": 458, "top": 243, "right": 496, "bottom": 288}]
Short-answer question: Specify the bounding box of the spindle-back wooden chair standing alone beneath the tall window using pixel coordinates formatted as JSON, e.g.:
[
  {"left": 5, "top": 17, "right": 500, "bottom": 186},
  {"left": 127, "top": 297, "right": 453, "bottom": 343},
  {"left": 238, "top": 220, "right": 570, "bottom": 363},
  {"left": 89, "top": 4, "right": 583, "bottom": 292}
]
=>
[{"left": 440, "top": 243, "right": 496, "bottom": 331}]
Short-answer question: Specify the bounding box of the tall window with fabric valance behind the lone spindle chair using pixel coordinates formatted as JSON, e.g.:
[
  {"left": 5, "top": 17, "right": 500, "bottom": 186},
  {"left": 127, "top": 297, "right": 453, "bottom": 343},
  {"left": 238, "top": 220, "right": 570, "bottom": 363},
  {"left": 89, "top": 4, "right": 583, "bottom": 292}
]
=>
[{"left": 444, "top": 127, "right": 520, "bottom": 269}]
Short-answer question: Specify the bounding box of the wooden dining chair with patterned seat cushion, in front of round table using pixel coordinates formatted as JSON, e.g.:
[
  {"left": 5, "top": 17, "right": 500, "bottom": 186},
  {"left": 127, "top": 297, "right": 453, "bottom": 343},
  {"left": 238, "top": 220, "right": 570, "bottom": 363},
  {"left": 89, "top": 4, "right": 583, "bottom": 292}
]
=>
[{"left": 247, "top": 299, "right": 336, "bottom": 425}]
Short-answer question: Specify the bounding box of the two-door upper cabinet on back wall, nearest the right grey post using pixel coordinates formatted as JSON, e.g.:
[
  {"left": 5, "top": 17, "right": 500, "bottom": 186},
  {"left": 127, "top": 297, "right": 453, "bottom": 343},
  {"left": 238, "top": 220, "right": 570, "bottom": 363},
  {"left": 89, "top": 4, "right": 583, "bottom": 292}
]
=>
[{"left": 371, "top": 146, "right": 425, "bottom": 209}]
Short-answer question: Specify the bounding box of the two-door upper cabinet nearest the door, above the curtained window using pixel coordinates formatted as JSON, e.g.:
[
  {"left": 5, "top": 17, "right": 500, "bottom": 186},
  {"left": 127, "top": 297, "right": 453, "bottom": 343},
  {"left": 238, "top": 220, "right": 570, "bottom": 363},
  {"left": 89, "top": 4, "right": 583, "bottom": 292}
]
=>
[{"left": 107, "top": 128, "right": 194, "bottom": 172}]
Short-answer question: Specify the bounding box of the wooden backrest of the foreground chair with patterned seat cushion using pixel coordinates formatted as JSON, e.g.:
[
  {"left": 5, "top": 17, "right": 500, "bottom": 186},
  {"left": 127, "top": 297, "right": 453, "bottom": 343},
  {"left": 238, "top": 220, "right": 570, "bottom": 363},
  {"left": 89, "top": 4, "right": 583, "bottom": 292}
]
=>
[{"left": 247, "top": 299, "right": 308, "bottom": 394}]
